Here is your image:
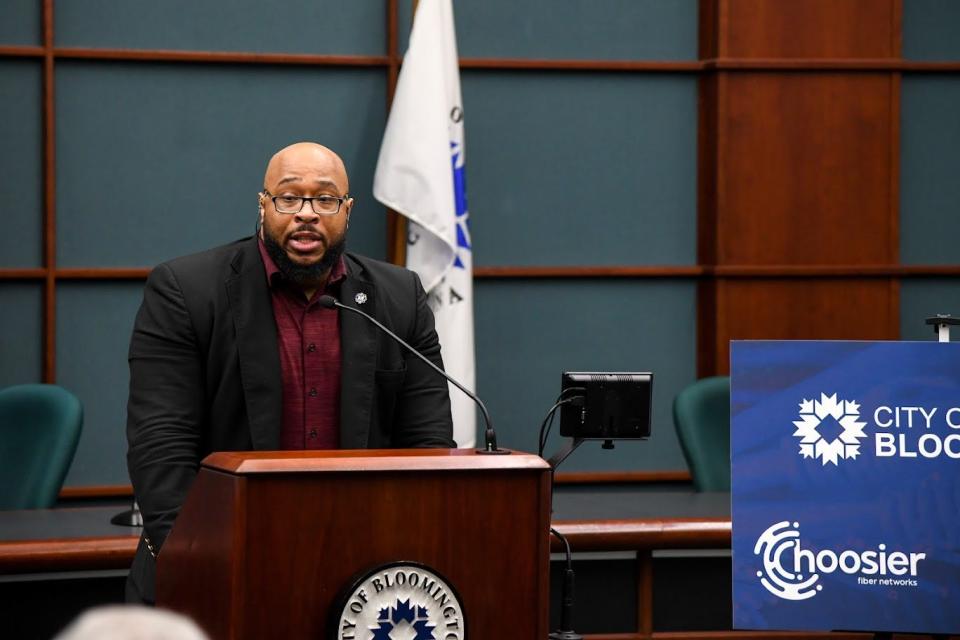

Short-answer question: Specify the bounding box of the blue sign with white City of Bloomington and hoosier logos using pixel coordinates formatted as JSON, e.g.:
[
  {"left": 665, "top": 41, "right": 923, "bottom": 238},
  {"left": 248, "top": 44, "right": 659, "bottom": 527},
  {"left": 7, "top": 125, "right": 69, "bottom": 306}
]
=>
[{"left": 730, "top": 341, "right": 960, "bottom": 634}]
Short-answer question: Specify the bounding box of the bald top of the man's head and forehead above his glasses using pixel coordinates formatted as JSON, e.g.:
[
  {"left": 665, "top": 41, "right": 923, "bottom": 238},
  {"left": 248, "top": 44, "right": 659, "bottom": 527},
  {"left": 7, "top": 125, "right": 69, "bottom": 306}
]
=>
[{"left": 263, "top": 142, "right": 350, "bottom": 196}]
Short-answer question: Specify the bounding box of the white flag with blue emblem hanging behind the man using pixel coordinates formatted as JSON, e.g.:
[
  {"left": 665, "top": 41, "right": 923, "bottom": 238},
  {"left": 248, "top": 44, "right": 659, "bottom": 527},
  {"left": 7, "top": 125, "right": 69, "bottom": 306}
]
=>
[{"left": 373, "top": 0, "right": 476, "bottom": 447}]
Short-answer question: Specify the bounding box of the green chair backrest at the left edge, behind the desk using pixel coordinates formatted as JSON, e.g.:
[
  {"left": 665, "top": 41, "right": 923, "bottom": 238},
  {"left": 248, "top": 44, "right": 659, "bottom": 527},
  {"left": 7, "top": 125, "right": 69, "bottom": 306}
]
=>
[{"left": 0, "top": 384, "right": 83, "bottom": 509}]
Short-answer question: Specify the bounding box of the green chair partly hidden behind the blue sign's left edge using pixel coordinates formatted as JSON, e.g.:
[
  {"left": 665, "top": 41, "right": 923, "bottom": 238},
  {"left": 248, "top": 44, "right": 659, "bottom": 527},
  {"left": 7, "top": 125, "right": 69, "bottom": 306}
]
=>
[{"left": 673, "top": 376, "right": 730, "bottom": 491}]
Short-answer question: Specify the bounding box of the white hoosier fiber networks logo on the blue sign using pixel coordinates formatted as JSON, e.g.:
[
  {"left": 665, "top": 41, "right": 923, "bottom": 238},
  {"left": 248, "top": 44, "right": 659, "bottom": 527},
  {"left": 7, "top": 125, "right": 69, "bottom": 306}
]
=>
[{"left": 753, "top": 520, "right": 927, "bottom": 600}]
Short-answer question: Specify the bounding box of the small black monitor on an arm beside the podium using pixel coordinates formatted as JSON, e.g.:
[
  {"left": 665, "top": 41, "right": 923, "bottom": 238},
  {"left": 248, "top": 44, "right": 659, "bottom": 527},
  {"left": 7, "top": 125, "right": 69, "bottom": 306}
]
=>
[{"left": 560, "top": 371, "right": 653, "bottom": 440}]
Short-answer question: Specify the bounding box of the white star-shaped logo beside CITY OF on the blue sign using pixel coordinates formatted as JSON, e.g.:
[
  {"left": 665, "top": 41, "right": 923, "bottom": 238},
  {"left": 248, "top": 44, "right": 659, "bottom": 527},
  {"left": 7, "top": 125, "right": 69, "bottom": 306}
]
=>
[{"left": 793, "top": 393, "right": 867, "bottom": 466}]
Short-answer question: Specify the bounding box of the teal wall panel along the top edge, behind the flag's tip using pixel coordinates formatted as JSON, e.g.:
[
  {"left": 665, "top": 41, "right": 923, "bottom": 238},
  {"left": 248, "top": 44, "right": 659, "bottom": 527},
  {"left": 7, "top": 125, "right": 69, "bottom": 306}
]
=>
[{"left": 399, "top": 0, "right": 697, "bottom": 60}]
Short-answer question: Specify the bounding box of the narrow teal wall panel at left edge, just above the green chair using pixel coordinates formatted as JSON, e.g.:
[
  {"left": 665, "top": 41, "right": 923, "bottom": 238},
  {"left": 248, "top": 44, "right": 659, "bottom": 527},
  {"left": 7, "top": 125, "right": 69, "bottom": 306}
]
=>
[{"left": 0, "top": 282, "right": 43, "bottom": 388}]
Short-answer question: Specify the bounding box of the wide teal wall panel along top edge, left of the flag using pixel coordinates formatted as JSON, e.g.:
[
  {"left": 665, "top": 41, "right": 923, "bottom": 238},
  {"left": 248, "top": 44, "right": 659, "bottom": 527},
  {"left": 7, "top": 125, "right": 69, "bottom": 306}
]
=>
[{"left": 54, "top": 0, "right": 387, "bottom": 55}]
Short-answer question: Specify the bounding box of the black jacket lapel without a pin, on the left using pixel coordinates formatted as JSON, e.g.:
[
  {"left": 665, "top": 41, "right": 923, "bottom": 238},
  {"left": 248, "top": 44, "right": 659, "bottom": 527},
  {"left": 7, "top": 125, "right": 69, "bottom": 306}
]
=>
[{"left": 226, "top": 238, "right": 283, "bottom": 450}]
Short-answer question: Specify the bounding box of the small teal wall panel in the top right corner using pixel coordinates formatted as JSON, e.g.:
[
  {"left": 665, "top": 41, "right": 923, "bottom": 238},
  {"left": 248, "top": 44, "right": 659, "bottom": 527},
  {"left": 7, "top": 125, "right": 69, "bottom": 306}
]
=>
[{"left": 903, "top": 0, "right": 960, "bottom": 60}]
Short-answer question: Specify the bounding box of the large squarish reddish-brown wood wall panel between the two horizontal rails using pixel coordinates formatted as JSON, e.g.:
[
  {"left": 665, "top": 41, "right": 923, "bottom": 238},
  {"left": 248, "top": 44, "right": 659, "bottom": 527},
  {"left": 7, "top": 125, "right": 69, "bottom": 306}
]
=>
[{"left": 716, "top": 72, "right": 897, "bottom": 265}]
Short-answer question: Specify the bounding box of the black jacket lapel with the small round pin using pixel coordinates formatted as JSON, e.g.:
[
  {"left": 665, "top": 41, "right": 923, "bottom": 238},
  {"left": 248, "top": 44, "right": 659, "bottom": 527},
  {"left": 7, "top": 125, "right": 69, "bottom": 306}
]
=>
[{"left": 338, "top": 258, "right": 378, "bottom": 449}]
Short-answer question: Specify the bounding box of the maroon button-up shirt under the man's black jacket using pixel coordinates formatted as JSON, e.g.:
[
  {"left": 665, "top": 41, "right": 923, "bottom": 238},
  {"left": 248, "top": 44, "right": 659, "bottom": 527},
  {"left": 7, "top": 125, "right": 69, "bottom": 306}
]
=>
[{"left": 259, "top": 240, "right": 347, "bottom": 449}]
